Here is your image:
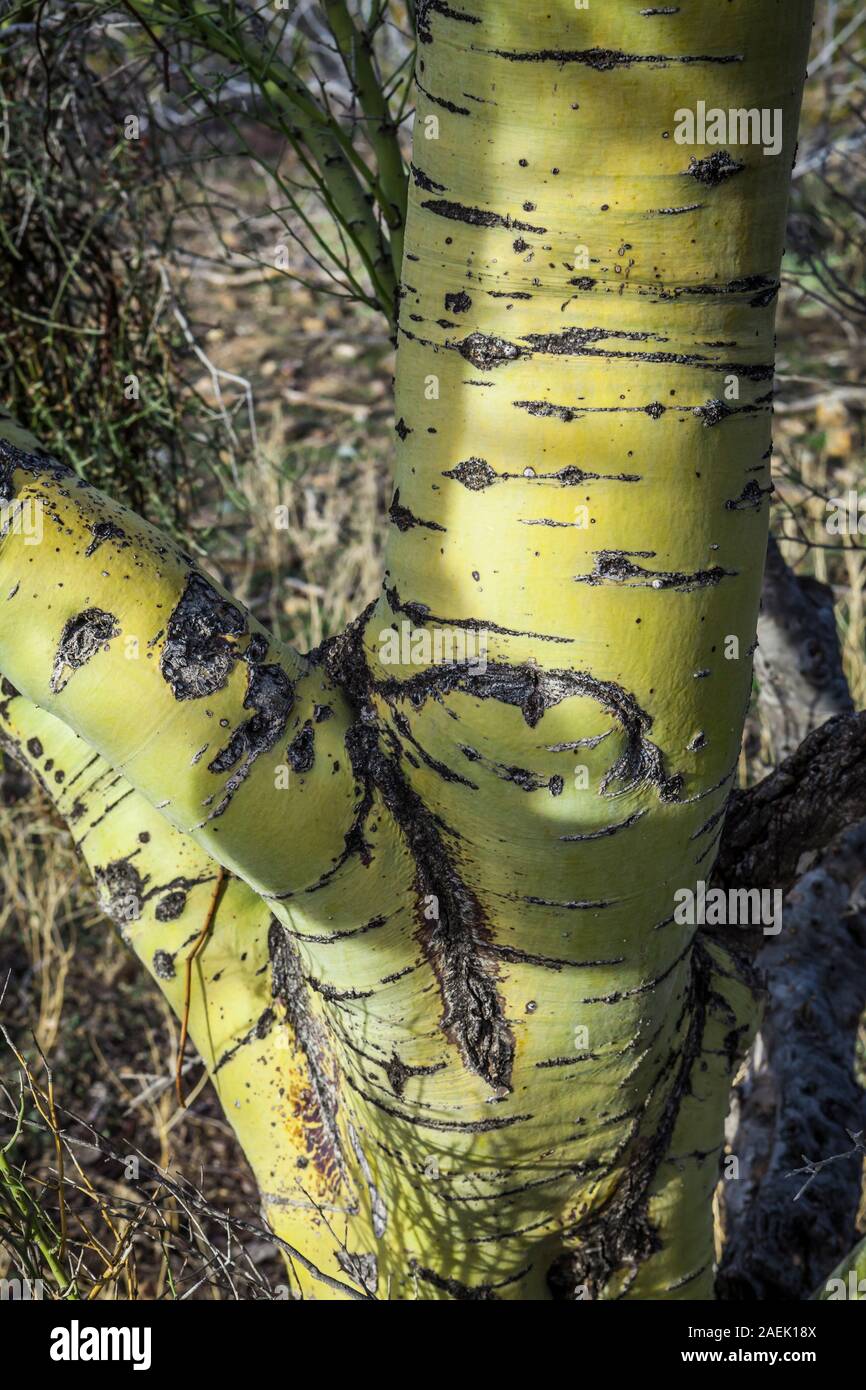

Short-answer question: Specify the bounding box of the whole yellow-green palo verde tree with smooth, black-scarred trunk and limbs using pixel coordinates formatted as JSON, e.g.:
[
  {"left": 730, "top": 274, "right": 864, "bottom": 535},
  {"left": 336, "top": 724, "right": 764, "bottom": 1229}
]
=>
[{"left": 0, "top": 0, "right": 862, "bottom": 1298}]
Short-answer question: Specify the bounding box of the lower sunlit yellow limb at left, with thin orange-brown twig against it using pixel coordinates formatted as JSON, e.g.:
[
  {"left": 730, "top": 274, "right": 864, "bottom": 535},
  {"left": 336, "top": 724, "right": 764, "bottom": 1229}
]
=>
[{"left": 0, "top": 680, "right": 366, "bottom": 1289}]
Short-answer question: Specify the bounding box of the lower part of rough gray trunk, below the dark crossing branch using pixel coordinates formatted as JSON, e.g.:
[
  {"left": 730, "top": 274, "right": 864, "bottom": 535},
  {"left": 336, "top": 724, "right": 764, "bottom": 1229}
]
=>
[{"left": 717, "top": 824, "right": 866, "bottom": 1300}]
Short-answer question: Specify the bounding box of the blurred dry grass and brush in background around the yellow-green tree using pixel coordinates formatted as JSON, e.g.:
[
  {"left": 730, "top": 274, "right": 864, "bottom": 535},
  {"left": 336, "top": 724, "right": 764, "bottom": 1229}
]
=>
[{"left": 0, "top": 0, "right": 866, "bottom": 1298}]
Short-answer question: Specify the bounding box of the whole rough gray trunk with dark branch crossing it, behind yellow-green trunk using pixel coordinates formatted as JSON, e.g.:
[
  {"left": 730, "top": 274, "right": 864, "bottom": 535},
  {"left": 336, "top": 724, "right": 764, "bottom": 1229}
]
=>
[{"left": 716, "top": 539, "right": 866, "bottom": 1300}]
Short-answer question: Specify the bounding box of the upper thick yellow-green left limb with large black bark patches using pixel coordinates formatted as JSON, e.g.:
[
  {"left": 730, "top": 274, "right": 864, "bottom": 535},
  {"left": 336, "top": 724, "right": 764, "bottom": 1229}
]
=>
[{"left": 0, "top": 430, "right": 356, "bottom": 895}]
